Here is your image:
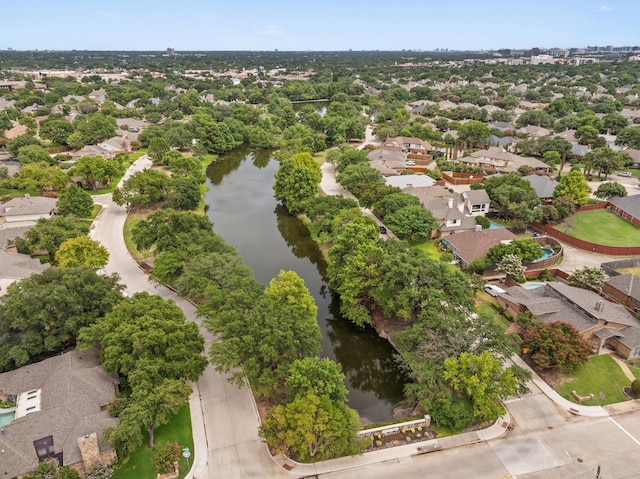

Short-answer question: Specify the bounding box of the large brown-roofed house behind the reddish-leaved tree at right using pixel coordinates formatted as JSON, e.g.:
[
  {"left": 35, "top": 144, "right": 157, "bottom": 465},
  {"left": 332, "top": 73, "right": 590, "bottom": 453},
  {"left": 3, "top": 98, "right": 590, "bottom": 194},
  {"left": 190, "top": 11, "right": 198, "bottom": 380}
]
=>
[{"left": 497, "top": 282, "right": 640, "bottom": 359}]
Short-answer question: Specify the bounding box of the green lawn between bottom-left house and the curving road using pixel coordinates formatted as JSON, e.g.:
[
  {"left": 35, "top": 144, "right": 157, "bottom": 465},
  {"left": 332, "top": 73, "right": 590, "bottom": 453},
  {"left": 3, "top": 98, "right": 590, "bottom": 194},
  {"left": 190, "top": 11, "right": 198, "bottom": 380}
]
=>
[{"left": 113, "top": 404, "right": 194, "bottom": 479}]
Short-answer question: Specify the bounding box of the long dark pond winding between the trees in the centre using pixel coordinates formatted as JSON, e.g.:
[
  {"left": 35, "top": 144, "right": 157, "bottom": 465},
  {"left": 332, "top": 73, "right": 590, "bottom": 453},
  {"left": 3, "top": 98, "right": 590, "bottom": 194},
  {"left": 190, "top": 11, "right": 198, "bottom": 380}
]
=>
[{"left": 205, "top": 148, "right": 406, "bottom": 422}]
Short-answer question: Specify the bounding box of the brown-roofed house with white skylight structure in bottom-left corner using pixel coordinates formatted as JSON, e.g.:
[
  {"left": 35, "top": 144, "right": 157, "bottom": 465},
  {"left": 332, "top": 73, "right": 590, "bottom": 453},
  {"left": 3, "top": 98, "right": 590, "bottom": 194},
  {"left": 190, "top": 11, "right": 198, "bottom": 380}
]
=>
[{"left": 0, "top": 351, "right": 118, "bottom": 478}]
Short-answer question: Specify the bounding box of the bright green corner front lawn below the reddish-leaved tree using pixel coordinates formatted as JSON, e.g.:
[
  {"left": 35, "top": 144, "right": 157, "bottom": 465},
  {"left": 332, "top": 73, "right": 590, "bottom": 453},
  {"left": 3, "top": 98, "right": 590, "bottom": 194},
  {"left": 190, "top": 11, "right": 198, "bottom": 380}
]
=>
[{"left": 555, "top": 355, "right": 630, "bottom": 406}]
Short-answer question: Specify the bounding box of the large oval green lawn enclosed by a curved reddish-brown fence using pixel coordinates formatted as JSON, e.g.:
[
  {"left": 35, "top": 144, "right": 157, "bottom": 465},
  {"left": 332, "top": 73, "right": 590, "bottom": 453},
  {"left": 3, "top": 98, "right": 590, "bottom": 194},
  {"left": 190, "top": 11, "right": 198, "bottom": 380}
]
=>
[{"left": 557, "top": 210, "right": 640, "bottom": 246}]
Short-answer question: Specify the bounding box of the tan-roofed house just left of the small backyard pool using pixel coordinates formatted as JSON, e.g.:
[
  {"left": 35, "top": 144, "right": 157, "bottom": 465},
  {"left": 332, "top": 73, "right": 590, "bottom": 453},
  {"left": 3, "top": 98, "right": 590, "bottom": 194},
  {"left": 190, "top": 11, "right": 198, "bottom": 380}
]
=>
[{"left": 442, "top": 228, "right": 517, "bottom": 267}]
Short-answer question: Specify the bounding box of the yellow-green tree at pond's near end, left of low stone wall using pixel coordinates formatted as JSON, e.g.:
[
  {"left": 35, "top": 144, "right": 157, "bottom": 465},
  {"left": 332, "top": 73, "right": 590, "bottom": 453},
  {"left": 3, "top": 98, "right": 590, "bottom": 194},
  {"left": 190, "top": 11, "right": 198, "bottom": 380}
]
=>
[{"left": 260, "top": 393, "right": 364, "bottom": 462}]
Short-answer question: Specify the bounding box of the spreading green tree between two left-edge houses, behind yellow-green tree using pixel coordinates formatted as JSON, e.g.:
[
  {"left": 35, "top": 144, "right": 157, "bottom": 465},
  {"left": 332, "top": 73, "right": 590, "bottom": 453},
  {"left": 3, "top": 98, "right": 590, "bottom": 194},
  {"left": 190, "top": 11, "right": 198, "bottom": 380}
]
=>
[{"left": 16, "top": 216, "right": 89, "bottom": 258}]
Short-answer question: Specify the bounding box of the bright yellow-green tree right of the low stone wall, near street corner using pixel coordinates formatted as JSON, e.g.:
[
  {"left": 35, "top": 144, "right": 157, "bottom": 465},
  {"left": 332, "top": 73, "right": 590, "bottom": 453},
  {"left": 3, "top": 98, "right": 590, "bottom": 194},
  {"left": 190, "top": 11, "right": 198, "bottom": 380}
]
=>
[{"left": 444, "top": 351, "right": 518, "bottom": 421}]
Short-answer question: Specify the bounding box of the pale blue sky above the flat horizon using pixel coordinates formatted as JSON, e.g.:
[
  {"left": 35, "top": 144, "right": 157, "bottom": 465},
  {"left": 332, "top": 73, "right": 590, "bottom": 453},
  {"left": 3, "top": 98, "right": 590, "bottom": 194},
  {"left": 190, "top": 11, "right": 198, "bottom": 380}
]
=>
[{"left": 5, "top": 0, "right": 640, "bottom": 53}]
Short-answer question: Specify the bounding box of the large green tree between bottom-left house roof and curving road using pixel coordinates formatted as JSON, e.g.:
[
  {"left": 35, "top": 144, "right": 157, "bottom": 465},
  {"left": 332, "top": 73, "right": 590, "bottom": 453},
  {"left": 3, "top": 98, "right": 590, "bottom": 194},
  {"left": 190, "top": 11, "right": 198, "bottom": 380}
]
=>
[{"left": 78, "top": 293, "right": 207, "bottom": 448}]
